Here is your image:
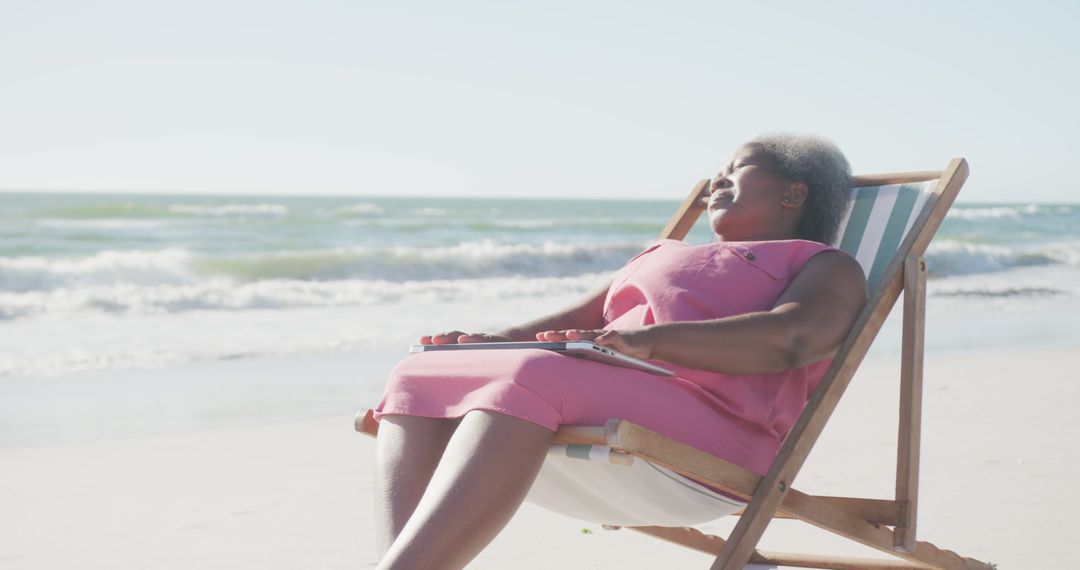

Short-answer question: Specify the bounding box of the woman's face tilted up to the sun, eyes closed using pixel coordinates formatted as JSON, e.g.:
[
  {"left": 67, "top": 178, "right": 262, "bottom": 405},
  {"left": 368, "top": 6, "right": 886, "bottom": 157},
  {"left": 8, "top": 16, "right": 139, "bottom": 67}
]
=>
[{"left": 708, "top": 145, "right": 801, "bottom": 242}]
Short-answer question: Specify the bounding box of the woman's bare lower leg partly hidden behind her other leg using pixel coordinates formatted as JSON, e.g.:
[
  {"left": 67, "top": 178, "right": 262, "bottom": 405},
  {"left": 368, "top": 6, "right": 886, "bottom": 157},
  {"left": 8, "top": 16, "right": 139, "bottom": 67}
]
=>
[{"left": 375, "top": 415, "right": 461, "bottom": 558}]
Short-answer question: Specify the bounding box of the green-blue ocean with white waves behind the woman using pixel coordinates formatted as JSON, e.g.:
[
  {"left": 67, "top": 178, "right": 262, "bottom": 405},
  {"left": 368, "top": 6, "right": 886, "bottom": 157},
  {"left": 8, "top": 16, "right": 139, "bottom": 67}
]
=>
[{"left": 0, "top": 192, "right": 1080, "bottom": 378}]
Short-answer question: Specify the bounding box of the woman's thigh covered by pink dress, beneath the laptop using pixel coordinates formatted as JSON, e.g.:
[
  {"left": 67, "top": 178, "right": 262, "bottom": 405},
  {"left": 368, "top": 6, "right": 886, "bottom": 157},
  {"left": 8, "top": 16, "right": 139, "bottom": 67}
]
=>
[{"left": 380, "top": 350, "right": 741, "bottom": 456}]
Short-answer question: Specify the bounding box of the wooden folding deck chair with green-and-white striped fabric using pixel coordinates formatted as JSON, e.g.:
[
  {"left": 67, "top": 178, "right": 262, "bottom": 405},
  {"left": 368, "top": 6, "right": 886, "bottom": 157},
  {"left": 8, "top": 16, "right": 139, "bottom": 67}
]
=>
[{"left": 355, "top": 159, "right": 994, "bottom": 570}]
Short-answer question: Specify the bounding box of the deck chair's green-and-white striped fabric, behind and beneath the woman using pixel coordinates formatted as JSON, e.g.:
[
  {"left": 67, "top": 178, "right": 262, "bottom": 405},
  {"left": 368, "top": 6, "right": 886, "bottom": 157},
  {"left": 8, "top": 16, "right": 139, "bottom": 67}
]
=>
[{"left": 526, "top": 180, "right": 936, "bottom": 527}]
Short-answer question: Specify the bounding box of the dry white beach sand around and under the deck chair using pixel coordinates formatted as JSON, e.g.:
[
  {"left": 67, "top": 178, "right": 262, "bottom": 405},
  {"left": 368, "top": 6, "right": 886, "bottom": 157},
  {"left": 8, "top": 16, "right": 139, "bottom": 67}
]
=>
[{"left": 0, "top": 349, "right": 1080, "bottom": 570}]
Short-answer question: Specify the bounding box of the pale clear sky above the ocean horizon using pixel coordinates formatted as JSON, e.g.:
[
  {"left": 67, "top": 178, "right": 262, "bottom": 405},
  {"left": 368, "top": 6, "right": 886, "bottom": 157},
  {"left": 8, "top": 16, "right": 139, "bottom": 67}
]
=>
[{"left": 0, "top": 0, "right": 1080, "bottom": 202}]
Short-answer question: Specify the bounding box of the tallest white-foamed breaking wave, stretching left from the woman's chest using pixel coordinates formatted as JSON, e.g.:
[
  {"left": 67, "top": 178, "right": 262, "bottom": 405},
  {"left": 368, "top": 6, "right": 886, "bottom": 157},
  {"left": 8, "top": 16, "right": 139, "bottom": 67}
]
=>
[{"left": 0, "top": 241, "right": 640, "bottom": 293}]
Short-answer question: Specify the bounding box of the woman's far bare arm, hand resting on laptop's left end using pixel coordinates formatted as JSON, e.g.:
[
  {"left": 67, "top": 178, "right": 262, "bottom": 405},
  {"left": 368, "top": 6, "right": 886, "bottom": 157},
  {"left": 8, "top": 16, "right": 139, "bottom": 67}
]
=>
[{"left": 420, "top": 281, "right": 611, "bottom": 344}]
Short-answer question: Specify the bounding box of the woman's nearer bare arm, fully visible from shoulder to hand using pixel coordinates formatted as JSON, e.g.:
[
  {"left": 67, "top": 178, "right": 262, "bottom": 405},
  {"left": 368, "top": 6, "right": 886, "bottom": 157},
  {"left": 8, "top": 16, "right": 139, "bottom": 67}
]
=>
[{"left": 544, "top": 252, "right": 867, "bottom": 375}]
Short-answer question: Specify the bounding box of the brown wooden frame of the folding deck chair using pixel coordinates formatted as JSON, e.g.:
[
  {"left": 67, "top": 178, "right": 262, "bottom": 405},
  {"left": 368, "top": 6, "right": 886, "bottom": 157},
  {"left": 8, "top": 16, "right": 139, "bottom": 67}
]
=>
[{"left": 355, "top": 159, "right": 995, "bottom": 570}]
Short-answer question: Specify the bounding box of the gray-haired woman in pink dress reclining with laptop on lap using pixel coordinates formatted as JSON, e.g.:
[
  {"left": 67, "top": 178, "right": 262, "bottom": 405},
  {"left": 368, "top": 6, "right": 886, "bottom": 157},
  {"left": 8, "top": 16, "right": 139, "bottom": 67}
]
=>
[{"left": 375, "top": 135, "right": 866, "bottom": 569}]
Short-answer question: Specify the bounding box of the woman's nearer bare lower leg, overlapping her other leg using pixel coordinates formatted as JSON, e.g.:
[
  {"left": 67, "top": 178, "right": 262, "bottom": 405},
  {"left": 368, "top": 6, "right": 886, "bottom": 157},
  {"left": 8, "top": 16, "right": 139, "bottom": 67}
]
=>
[{"left": 379, "top": 410, "right": 555, "bottom": 570}]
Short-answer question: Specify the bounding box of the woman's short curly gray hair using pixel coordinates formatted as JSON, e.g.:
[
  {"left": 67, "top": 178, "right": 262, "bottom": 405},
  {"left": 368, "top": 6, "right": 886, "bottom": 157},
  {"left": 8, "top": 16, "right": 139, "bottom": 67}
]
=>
[{"left": 750, "top": 134, "right": 851, "bottom": 245}]
